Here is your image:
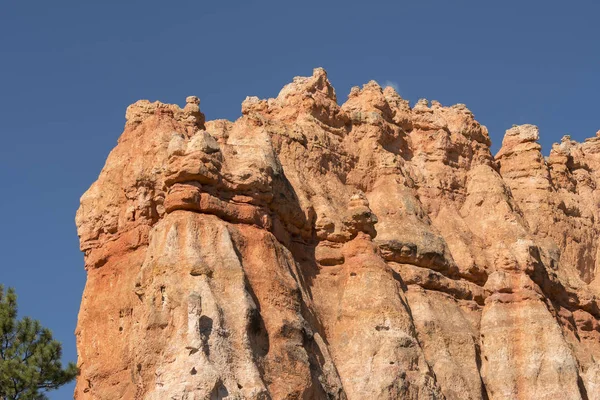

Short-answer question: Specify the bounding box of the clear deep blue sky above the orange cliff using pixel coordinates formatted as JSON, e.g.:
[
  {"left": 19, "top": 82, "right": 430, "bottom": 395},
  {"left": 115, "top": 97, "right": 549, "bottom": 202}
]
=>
[{"left": 0, "top": 0, "right": 600, "bottom": 399}]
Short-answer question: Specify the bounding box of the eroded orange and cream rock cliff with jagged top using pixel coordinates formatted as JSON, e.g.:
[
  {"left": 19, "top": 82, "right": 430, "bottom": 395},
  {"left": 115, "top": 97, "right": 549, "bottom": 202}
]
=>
[{"left": 75, "top": 68, "right": 600, "bottom": 400}]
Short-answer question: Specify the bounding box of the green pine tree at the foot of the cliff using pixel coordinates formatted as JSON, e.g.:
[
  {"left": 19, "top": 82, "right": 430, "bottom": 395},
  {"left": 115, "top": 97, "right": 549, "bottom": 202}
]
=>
[{"left": 0, "top": 285, "right": 77, "bottom": 400}]
